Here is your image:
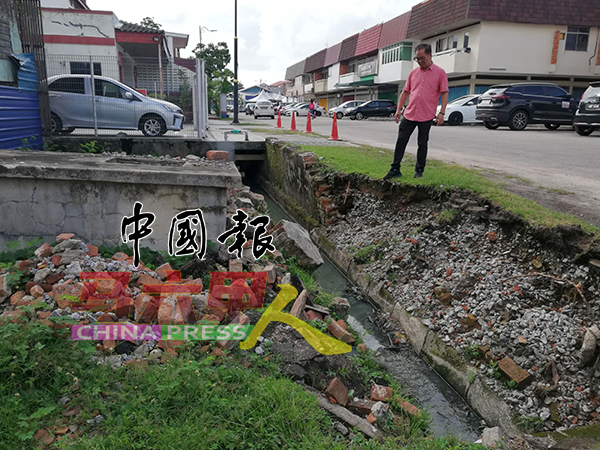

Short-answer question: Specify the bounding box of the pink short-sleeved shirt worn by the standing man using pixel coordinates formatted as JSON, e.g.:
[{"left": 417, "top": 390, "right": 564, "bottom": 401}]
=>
[{"left": 404, "top": 63, "right": 448, "bottom": 122}]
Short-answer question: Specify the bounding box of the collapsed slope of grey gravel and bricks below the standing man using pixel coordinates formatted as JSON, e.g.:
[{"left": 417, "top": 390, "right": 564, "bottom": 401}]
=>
[{"left": 327, "top": 191, "right": 600, "bottom": 430}]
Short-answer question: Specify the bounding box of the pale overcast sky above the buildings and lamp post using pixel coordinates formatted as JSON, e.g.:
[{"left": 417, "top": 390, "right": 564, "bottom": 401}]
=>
[{"left": 87, "top": 0, "right": 418, "bottom": 87}]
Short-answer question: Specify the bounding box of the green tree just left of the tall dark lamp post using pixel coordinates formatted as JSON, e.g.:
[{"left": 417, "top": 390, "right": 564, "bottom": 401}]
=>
[{"left": 193, "top": 42, "right": 233, "bottom": 112}]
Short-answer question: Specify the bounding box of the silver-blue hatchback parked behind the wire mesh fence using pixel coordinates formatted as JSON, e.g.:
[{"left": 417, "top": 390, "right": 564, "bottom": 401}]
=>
[{"left": 48, "top": 75, "right": 185, "bottom": 137}]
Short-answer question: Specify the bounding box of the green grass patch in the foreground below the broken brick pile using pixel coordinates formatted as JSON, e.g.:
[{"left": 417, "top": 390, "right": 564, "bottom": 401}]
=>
[{"left": 0, "top": 322, "right": 480, "bottom": 450}]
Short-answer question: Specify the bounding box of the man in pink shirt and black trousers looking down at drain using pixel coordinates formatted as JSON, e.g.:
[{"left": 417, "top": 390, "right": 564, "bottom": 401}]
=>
[{"left": 383, "top": 44, "right": 448, "bottom": 180}]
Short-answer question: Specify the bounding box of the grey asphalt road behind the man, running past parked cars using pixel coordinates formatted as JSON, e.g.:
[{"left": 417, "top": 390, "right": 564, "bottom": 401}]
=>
[{"left": 246, "top": 117, "right": 600, "bottom": 225}]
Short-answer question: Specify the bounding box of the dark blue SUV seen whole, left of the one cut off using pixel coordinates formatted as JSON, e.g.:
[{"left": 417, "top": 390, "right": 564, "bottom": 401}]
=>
[{"left": 475, "top": 83, "right": 579, "bottom": 130}]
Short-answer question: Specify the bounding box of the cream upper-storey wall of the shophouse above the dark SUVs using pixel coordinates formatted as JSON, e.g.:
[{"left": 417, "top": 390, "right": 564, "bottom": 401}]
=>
[{"left": 477, "top": 22, "right": 598, "bottom": 76}]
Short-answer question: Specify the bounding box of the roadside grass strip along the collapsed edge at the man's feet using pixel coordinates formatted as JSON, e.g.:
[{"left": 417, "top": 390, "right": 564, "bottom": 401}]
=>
[{"left": 302, "top": 146, "right": 600, "bottom": 238}]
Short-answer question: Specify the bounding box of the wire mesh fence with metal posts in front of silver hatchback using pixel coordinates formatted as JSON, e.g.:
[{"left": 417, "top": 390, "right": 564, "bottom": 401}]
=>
[{"left": 46, "top": 54, "right": 206, "bottom": 138}]
